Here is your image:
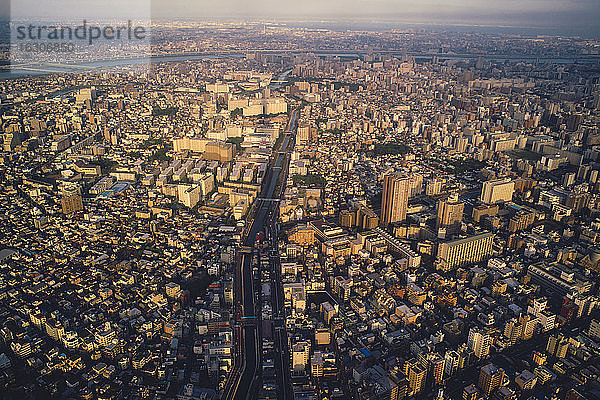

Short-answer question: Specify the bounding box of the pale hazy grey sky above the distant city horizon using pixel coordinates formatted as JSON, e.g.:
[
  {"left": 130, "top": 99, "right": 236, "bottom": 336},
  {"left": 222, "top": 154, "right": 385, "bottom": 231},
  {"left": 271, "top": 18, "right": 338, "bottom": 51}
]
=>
[{"left": 8, "top": 0, "right": 600, "bottom": 32}]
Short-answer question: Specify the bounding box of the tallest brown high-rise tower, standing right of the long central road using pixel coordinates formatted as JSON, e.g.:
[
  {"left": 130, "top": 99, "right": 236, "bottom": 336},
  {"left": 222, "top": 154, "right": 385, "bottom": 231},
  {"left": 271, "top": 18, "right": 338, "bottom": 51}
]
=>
[{"left": 381, "top": 174, "right": 410, "bottom": 226}]
